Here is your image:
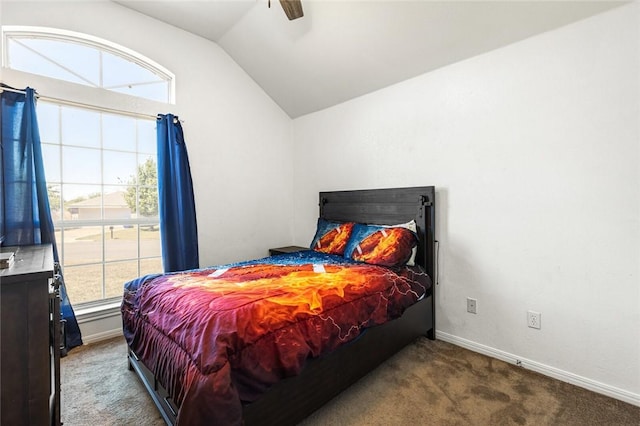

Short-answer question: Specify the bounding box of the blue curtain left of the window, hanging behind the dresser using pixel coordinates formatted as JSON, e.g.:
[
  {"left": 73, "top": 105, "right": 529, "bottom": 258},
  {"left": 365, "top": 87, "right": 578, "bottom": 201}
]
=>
[{"left": 0, "top": 87, "right": 82, "bottom": 349}]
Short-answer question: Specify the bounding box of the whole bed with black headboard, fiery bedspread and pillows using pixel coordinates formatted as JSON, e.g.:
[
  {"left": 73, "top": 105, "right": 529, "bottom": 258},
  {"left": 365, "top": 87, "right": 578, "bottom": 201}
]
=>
[{"left": 122, "top": 186, "right": 435, "bottom": 426}]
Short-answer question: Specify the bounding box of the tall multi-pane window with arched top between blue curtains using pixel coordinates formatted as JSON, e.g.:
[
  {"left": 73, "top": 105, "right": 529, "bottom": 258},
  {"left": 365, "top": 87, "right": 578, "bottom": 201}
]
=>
[{"left": 2, "top": 27, "right": 174, "bottom": 308}]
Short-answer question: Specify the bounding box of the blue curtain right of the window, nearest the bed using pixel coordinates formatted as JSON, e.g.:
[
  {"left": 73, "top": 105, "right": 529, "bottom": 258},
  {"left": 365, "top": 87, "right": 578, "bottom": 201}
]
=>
[{"left": 157, "top": 114, "right": 200, "bottom": 272}]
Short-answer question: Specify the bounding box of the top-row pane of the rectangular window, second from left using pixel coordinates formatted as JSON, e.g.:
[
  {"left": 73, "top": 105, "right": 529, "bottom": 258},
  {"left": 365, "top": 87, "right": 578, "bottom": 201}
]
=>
[{"left": 62, "top": 108, "right": 100, "bottom": 148}]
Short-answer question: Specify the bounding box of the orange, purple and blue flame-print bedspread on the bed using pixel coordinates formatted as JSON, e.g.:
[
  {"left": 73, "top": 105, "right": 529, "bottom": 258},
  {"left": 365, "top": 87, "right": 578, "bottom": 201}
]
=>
[{"left": 122, "top": 251, "right": 431, "bottom": 425}]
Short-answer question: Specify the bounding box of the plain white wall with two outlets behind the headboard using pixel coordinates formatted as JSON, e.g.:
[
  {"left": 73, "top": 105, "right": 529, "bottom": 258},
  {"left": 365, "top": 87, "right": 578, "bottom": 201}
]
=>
[{"left": 294, "top": 4, "right": 640, "bottom": 405}]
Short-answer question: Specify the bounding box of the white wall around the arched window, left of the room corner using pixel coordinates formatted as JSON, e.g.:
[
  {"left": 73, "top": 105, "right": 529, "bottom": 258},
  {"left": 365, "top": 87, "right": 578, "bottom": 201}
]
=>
[{"left": 0, "top": 1, "right": 293, "bottom": 266}]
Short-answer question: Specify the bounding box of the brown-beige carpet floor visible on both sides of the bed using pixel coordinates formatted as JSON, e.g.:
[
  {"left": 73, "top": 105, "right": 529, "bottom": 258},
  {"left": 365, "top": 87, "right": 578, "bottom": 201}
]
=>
[{"left": 62, "top": 338, "right": 640, "bottom": 426}]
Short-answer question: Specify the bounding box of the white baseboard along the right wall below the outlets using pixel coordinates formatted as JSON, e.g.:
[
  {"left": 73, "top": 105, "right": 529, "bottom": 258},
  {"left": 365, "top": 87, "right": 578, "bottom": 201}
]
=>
[{"left": 436, "top": 331, "right": 640, "bottom": 407}]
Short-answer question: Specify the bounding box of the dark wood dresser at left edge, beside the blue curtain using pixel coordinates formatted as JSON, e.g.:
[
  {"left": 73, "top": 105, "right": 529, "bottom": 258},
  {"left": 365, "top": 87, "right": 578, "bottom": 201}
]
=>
[{"left": 0, "top": 244, "right": 60, "bottom": 426}]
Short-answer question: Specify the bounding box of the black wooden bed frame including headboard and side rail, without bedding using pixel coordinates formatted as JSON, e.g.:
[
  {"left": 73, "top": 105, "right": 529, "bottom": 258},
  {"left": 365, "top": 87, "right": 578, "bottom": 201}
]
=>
[{"left": 129, "top": 186, "right": 436, "bottom": 426}]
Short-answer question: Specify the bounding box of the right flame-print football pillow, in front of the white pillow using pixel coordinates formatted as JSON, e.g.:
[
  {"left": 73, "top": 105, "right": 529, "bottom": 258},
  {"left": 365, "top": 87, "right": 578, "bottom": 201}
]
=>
[{"left": 344, "top": 223, "right": 418, "bottom": 266}]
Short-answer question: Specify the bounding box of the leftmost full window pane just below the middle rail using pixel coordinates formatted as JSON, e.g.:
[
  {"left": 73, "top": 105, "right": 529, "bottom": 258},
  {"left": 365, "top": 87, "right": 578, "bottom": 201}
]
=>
[{"left": 63, "top": 226, "right": 102, "bottom": 266}]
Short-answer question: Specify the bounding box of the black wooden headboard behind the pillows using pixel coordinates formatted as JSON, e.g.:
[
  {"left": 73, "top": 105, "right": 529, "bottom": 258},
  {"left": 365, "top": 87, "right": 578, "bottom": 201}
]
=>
[{"left": 320, "top": 186, "right": 435, "bottom": 285}]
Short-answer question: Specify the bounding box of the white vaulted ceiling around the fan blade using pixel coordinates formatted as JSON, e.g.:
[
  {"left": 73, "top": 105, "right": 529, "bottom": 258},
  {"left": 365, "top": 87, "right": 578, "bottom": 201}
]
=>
[{"left": 117, "top": 0, "right": 624, "bottom": 118}]
